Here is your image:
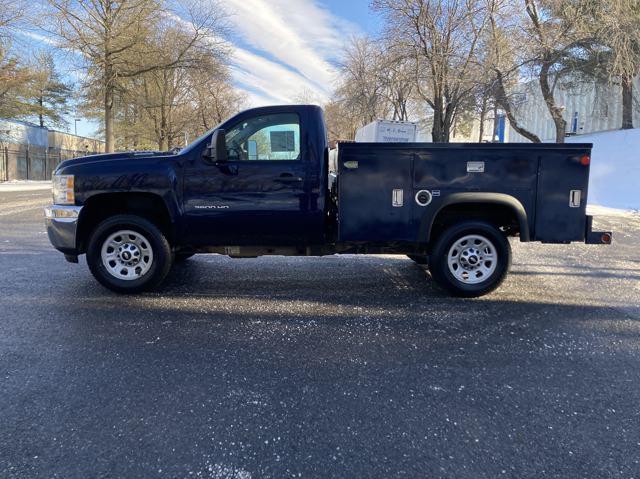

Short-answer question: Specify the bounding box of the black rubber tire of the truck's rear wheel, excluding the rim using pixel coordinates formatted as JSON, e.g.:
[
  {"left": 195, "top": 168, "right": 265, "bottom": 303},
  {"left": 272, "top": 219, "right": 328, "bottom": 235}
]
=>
[{"left": 429, "top": 221, "right": 511, "bottom": 298}]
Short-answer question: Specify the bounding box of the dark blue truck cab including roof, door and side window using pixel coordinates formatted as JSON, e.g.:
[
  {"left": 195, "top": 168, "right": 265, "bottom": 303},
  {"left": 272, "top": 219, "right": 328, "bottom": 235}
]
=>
[{"left": 179, "top": 106, "right": 327, "bottom": 247}]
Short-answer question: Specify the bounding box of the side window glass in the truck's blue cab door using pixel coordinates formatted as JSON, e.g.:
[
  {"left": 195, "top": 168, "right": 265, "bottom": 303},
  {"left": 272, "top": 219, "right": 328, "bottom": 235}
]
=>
[{"left": 225, "top": 113, "right": 300, "bottom": 161}]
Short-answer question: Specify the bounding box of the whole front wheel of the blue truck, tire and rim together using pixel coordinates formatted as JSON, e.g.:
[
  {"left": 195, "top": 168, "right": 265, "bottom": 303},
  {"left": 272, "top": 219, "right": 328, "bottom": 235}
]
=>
[{"left": 87, "top": 215, "right": 171, "bottom": 293}]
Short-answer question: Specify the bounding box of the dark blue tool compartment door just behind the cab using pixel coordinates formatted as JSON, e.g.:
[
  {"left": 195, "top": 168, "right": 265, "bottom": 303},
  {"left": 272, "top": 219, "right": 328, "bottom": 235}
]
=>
[{"left": 338, "top": 143, "right": 415, "bottom": 242}]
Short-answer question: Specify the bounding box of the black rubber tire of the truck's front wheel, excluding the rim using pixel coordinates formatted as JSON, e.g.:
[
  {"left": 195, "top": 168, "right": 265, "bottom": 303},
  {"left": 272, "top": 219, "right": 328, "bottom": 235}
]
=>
[{"left": 87, "top": 215, "right": 172, "bottom": 293}]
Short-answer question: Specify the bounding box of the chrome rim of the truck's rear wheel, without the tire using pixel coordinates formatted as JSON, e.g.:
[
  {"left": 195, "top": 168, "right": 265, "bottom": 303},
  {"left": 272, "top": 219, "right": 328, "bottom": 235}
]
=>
[{"left": 447, "top": 235, "right": 498, "bottom": 284}]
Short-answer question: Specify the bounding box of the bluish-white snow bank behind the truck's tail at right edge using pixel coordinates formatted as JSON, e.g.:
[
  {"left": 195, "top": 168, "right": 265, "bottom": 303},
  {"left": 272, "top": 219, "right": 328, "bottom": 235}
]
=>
[{"left": 567, "top": 128, "right": 640, "bottom": 210}]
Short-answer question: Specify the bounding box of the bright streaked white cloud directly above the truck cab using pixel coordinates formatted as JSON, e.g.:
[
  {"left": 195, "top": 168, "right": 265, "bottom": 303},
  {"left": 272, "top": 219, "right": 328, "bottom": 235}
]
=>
[{"left": 223, "top": 0, "right": 358, "bottom": 103}]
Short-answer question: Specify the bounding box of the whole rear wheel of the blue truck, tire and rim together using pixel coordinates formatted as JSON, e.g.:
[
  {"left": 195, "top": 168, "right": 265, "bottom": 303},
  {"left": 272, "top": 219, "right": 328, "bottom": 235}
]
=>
[{"left": 429, "top": 221, "right": 511, "bottom": 298}]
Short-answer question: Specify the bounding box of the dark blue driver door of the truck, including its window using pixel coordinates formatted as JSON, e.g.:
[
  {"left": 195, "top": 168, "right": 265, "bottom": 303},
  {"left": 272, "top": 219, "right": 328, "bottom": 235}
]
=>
[{"left": 184, "top": 112, "right": 309, "bottom": 246}]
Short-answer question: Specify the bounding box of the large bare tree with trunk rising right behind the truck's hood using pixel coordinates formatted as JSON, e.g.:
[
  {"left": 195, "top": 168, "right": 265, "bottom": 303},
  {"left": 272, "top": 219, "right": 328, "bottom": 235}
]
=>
[{"left": 48, "top": 0, "right": 229, "bottom": 151}]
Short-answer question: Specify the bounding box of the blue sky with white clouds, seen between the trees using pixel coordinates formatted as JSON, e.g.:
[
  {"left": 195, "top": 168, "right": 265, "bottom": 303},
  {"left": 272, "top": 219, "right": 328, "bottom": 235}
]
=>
[{"left": 21, "top": 0, "right": 380, "bottom": 136}]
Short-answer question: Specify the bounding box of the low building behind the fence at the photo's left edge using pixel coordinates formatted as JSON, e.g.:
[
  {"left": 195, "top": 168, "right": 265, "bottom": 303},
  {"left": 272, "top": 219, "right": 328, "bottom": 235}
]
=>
[{"left": 0, "top": 119, "right": 104, "bottom": 181}]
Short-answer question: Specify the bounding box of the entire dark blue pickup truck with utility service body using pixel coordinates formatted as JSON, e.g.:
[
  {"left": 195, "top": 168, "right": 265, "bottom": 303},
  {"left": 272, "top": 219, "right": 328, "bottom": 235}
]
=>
[{"left": 45, "top": 105, "right": 611, "bottom": 297}]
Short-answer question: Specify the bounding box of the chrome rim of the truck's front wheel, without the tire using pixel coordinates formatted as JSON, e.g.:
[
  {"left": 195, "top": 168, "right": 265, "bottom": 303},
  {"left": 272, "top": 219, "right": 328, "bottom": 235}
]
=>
[{"left": 101, "top": 230, "right": 153, "bottom": 281}]
